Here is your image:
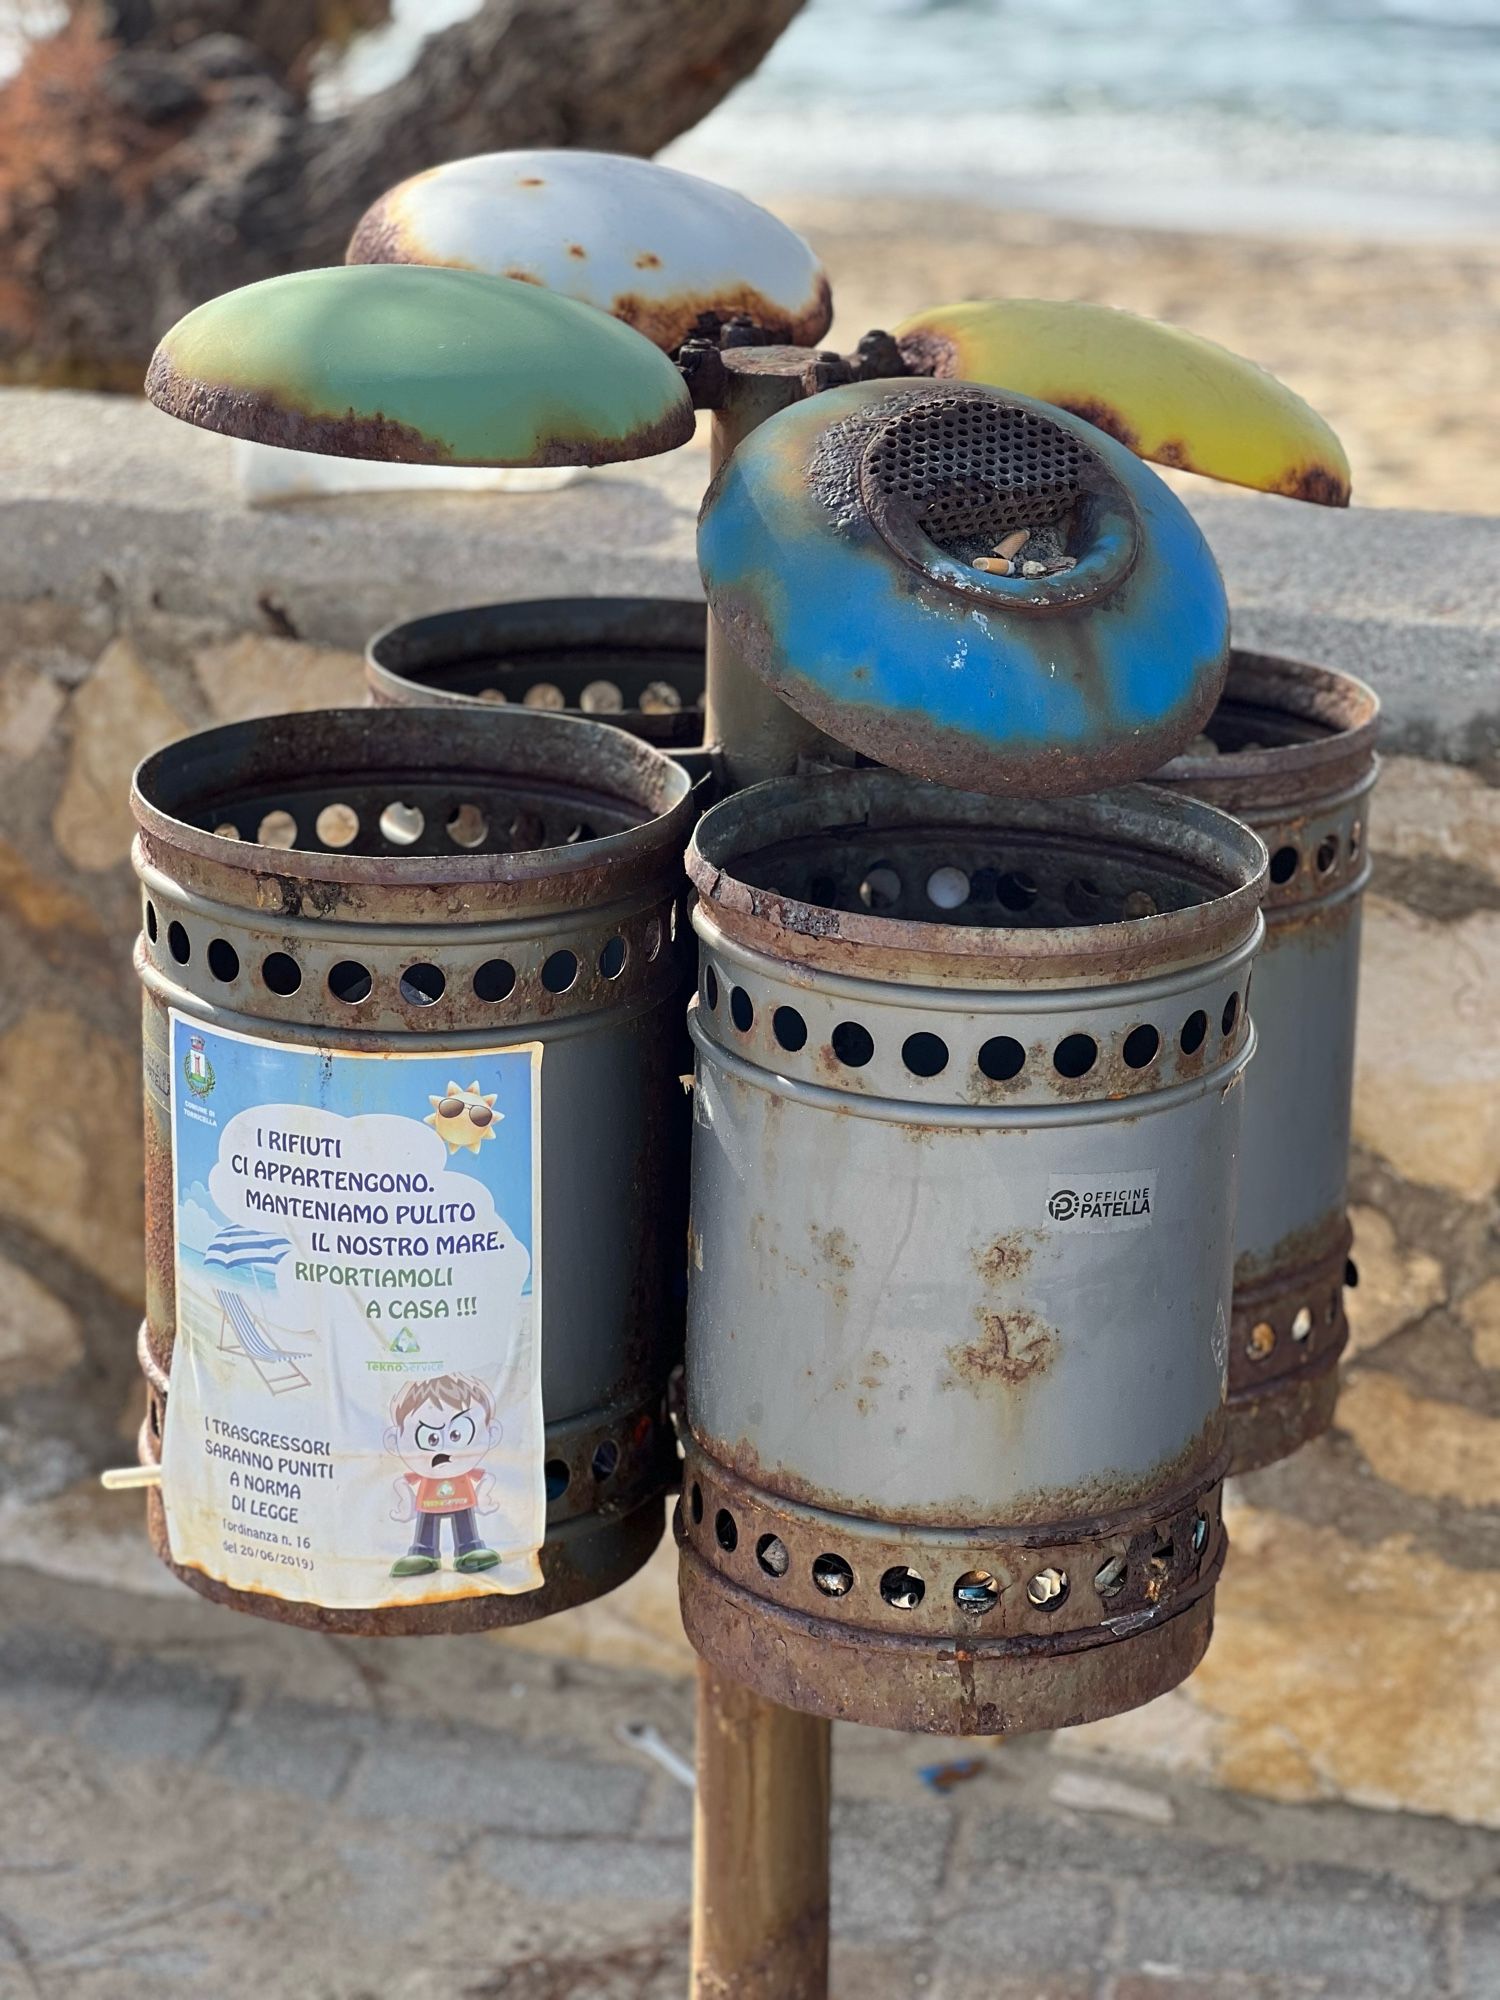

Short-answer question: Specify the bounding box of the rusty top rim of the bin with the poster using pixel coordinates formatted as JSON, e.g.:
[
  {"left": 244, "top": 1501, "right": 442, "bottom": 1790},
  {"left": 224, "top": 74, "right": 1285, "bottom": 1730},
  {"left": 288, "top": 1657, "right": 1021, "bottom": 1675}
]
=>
[{"left": 130, "top": 706, "right": 692, "bottom": 890}]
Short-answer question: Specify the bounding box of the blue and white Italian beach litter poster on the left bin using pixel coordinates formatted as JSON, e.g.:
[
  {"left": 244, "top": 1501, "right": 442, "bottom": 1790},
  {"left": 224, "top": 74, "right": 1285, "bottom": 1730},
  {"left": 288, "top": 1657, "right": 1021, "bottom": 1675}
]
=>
[{"left": 162, "top": 1010, "right": 546, "bottom": 1608}]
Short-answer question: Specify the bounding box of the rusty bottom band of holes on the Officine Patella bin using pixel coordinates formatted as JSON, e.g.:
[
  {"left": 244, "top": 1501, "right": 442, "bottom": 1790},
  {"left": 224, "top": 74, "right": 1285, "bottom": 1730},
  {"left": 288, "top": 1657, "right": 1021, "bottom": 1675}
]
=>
[{"left": 678, "top": 1478, "right": 1216, "bottom": 1630}]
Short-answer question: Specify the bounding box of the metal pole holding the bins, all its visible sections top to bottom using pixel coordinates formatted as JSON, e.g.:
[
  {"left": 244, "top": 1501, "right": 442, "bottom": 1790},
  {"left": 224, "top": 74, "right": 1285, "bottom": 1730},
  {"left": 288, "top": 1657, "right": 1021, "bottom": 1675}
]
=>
[{"left": 692, "top": 348, "right": 848, "bottom": 2000}]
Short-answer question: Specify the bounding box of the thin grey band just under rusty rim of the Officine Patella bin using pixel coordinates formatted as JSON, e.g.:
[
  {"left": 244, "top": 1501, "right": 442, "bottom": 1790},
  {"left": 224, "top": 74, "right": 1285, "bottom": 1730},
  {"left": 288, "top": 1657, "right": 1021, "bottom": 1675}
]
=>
[{"left": 692, "top": 902, "right": 1268, "bottom": 1014}]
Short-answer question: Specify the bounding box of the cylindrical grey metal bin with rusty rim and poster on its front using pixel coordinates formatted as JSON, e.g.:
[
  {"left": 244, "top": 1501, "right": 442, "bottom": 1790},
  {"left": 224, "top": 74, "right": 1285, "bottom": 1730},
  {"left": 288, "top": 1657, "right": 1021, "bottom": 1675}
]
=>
[{"left": 132, "top": 708, "right": 692, "bottom": 1634}]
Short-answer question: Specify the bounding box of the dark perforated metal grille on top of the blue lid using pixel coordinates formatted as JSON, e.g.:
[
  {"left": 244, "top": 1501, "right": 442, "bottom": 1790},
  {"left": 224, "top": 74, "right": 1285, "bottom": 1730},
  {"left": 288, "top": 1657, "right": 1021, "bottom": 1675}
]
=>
[{"left": 868, "top": 396, "right": 1092, "bottom": 556}]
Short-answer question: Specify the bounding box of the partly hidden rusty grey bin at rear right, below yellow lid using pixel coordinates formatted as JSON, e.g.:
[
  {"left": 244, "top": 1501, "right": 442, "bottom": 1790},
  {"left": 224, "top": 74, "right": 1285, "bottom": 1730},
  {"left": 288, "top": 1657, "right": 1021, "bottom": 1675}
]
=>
[{"left": 1156, "top": 652, "right": 1380, "bottom": 1472}]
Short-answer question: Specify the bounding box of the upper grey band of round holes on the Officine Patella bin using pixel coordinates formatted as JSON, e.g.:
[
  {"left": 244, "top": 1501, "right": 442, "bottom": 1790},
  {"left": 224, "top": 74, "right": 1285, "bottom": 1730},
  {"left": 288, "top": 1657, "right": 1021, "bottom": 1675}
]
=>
[{"left": 700, "top": 964, "right": 1250, "bottom": 1090}]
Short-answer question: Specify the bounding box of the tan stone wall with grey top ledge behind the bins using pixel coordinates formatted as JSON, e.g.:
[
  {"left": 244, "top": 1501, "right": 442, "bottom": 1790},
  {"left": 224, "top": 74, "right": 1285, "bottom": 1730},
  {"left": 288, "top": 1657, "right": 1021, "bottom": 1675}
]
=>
[{"left": 0, "top": 392, "right": 1500, "bottom": 1824}]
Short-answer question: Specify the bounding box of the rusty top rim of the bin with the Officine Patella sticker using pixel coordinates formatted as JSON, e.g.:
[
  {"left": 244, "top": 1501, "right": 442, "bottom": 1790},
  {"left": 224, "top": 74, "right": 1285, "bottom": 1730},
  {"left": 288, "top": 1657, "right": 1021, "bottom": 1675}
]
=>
[{"left": 688, "top": 770, "right": 1268, "bottom": 984}]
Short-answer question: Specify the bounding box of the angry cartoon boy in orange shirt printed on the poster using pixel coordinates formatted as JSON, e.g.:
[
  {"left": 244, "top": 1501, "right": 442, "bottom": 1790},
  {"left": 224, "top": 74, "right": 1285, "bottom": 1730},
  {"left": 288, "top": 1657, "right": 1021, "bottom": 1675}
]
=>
[{"left": 386, "top": 1374, "right": 500, "bottom": 1576}]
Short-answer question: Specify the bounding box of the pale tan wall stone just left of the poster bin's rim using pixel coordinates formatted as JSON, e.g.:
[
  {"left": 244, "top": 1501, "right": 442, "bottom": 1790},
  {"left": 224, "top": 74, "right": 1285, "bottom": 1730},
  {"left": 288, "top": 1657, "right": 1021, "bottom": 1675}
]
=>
[{"left": 52, "top": 638, "right": 186, "bottom": 870}]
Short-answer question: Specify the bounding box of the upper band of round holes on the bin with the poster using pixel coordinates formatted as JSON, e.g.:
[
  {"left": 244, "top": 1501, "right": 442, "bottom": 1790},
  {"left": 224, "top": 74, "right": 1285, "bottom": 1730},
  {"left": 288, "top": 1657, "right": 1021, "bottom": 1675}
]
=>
[{"left": 146, "top": 900, "right": 676, "bottom": 1008}]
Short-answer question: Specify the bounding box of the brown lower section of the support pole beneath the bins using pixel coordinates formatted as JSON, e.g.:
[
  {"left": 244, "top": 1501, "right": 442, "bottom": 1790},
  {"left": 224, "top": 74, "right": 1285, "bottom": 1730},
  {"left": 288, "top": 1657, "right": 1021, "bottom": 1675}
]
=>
[{"left": 692, "top": 1660, "right": 832, "bottom": 2000}]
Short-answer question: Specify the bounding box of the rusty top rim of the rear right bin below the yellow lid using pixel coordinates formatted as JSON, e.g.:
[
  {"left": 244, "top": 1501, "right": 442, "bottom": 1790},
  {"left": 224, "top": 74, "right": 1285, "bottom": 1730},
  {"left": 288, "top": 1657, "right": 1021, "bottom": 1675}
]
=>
[{"left": 1154, "top": 648, "right": 1380, "bottom": 812}]
